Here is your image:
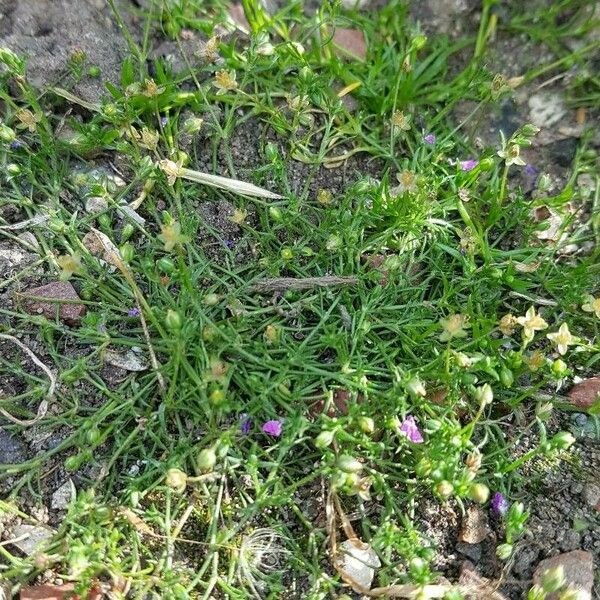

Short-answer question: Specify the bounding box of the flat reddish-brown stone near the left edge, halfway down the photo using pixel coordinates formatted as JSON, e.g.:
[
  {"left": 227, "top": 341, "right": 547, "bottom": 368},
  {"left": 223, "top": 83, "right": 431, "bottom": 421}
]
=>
[{"left": 23, "top": 281, "right": 85, "bottom": 325}]
